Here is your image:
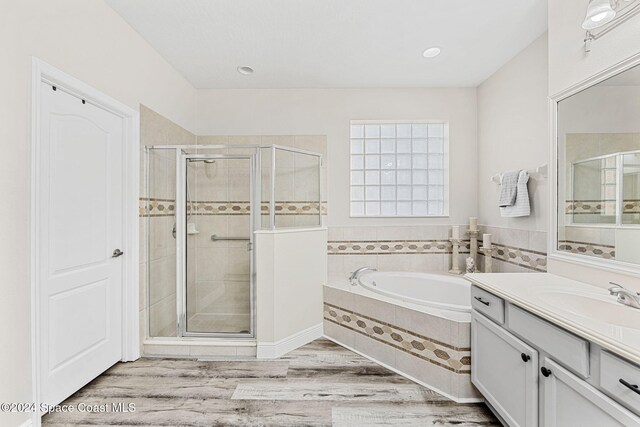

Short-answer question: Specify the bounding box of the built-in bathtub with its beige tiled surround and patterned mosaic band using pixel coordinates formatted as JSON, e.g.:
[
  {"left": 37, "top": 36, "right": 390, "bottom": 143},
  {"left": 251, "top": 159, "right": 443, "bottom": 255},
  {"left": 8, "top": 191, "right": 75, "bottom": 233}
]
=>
[{"left": 323, "top": 271, "right": 482, "bottom": 403}]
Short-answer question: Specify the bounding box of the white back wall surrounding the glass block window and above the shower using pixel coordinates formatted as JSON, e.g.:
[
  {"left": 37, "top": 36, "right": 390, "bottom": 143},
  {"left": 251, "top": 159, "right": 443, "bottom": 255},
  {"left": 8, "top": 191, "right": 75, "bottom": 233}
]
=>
[{"left": 196, "top": 88, "right": 477, "bottom": 226}]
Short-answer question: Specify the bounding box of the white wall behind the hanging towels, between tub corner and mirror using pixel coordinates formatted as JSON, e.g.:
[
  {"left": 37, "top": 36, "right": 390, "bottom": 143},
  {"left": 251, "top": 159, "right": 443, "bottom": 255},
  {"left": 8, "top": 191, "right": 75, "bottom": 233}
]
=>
[{"left": 478, "top": 34, "right": 549, "bottom": 231}]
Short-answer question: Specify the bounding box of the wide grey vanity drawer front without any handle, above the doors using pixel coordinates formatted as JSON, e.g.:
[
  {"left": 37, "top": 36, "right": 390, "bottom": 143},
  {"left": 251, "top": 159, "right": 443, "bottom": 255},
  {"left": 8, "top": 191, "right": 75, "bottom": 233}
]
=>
[{"left": 507, "top": 304, "right": 589, "bottom": 378}]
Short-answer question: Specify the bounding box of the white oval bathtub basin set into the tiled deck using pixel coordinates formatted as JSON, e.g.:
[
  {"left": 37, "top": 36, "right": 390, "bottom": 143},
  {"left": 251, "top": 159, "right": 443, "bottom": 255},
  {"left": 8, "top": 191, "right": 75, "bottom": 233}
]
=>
[{"left": 358, "top": 271, "right": 471, "bottom": 313}]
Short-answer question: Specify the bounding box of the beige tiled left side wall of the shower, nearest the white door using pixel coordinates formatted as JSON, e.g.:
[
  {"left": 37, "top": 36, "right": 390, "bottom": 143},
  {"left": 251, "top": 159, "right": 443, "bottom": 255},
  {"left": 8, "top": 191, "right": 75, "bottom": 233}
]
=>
[{"left": 140, "top": 105, "right": 195, "bottom": 339}]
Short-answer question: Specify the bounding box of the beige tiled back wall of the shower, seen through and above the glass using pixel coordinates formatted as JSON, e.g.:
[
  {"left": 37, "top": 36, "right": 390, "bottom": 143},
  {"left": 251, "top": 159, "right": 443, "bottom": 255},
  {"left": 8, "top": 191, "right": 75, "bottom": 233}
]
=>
[{"left": 187, "top": 136, "right": 326, "bottom": 331}]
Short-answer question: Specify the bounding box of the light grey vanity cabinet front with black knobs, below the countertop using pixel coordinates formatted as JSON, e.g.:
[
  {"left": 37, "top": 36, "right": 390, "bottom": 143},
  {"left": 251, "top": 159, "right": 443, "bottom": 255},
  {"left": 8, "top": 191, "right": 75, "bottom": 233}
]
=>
[{"left": 471, "top": 286, "right": 640, "bottom": 427}]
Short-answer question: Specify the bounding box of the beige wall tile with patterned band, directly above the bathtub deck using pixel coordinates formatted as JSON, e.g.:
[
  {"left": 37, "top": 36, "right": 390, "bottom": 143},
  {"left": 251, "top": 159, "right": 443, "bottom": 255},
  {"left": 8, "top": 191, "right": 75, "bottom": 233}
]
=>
[{"left": 327, "top": 225, "right": 547, "bottom": 281}]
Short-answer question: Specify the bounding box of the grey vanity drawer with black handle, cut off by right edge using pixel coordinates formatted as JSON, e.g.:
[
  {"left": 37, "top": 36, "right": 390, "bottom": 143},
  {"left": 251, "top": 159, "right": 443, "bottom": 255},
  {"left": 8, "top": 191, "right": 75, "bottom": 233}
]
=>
[{"left": 600, "top": 351, "right": 640, "bottom": 415}]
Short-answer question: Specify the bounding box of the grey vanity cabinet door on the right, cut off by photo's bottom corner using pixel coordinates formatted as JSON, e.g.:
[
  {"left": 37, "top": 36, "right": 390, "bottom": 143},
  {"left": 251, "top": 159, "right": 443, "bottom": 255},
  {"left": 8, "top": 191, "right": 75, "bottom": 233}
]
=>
[{"left": 541, "top": 358, "right": 640, "bottom": 427}]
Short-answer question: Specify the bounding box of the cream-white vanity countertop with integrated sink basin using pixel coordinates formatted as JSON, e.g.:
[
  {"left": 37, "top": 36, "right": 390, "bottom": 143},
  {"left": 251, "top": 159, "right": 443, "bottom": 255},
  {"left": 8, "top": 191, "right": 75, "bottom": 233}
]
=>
[{"left": 465, "top": 273, "right": 640, "bottom": 365}]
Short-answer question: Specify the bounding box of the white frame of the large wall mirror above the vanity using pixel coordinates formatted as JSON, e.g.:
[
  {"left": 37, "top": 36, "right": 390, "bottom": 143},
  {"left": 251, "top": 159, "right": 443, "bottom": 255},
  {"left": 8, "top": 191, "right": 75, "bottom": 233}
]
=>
[{"left": 547, "top": 54, "right": 640, "bottom": 277}]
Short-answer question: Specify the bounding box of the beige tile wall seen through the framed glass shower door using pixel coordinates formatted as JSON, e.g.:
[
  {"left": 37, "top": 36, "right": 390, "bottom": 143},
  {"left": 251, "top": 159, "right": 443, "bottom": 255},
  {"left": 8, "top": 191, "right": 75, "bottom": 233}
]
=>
[{"left": 187, "top": 159, "right": 251, "bottom": 333}]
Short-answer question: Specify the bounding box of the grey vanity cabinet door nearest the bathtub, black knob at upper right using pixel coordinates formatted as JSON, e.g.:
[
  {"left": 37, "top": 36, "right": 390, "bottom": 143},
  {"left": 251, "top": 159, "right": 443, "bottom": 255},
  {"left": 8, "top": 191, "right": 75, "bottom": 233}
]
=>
[{"left": 471, "top": 311, "right": 538, "bottom": 427}]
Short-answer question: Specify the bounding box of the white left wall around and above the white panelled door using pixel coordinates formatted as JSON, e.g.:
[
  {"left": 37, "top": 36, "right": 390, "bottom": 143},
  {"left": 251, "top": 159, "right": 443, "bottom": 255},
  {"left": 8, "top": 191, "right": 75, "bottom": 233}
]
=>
[{"left": 0, "top": 0, "right": 196, "bottom": 426}]
